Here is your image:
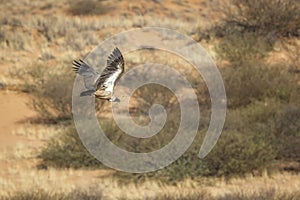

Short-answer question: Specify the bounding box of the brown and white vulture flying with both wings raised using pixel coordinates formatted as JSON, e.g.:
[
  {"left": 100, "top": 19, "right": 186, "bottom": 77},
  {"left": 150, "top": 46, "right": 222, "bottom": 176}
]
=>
[{"left": 73, "top": 48, "right": 124, "bottom": 101}]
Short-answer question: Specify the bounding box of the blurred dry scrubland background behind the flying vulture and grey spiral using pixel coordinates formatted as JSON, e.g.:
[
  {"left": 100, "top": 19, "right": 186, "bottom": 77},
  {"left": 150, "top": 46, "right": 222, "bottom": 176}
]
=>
[{"left": 0, "top": 0, "right": 300, "bottom": 200}]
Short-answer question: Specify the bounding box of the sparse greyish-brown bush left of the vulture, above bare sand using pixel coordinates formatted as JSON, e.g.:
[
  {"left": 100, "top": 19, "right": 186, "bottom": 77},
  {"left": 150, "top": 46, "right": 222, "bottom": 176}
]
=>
[{"left": 11, "top": 63, "right": 74, "bottom": 120}]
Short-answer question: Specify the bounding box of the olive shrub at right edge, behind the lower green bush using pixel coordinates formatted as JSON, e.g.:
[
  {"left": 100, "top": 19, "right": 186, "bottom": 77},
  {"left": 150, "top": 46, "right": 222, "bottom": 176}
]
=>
[{"left": 224, "top": 98, "right": 300, "bottom": 166}]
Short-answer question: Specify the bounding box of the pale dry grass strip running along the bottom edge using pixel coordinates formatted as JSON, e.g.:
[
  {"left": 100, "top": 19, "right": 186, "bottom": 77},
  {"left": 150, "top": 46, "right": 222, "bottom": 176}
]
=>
[{"left": 0, "top": 166, "right": 300, "bottom": 199}]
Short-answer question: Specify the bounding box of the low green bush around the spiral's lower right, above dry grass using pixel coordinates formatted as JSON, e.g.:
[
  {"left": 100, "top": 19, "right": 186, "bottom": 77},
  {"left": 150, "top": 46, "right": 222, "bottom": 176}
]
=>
[{"left": 114, "top": 126, "right": 276, "bottom": 184}]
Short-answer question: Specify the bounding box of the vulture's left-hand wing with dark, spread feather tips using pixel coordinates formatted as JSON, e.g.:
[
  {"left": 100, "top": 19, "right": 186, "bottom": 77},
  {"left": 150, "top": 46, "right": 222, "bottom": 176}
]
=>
[{"left": 73, "top": 60, "right": 100, "bottom": 91}]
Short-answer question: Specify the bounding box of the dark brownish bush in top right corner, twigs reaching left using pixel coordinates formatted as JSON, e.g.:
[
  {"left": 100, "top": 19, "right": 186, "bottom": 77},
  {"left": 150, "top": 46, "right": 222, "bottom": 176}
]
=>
[{"left": 199, "top": 0, "right": 300, "bottom": 41}]
